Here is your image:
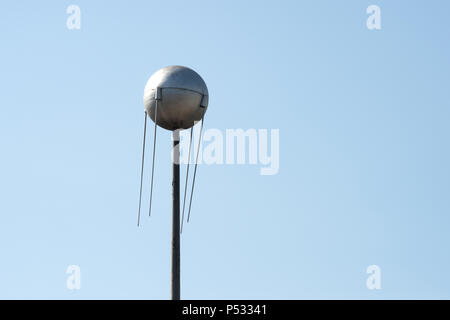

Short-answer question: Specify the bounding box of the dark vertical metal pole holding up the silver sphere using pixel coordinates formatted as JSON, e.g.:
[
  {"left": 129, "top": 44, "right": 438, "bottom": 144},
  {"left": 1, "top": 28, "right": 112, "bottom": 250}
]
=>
[{"left": 172, "top": 130, "right": 180, "bottom": 300}]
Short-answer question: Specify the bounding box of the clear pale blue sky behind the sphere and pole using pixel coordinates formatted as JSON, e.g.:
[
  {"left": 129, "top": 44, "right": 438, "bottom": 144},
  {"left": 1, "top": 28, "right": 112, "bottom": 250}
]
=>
[{"left": 0, "top": 0, "right": 450, "bottom": 299}]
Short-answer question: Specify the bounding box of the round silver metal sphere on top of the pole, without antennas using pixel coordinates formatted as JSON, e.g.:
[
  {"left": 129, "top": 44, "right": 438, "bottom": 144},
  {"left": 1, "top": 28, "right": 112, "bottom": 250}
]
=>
[{"left": 144, "top": 66, "right": 208, "bottom": 130}]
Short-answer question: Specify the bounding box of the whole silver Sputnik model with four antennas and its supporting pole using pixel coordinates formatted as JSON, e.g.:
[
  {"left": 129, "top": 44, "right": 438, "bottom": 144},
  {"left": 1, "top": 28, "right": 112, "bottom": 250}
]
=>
[{"left": 138, "top": 66, "right": 209, "bottom": 300}]
